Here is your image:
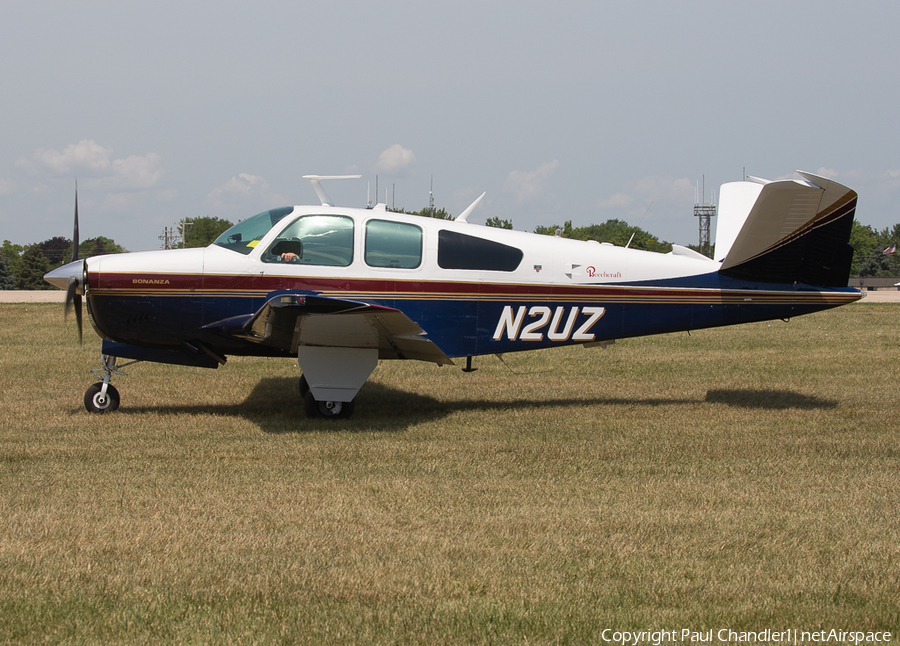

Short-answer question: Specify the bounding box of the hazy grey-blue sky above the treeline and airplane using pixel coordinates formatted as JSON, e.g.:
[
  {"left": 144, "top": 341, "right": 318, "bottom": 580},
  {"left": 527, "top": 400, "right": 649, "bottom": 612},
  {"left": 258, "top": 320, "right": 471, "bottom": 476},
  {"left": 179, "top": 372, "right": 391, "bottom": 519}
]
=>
[{"left": 0, "top": 0, "right": 900, "bottom": 251}]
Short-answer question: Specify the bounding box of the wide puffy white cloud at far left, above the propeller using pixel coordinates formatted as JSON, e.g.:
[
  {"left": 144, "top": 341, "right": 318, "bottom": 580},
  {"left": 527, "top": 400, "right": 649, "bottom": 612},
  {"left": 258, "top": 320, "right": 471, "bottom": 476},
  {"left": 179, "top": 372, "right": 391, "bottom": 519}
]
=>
[{"left": 15, "top": 139, "right": 165, "bottom": 191}]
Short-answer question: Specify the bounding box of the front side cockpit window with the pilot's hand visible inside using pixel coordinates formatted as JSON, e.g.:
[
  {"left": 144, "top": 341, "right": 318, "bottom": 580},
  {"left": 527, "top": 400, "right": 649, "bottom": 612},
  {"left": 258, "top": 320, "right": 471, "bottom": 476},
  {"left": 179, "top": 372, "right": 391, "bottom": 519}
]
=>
[{"left": 262, "top": 215, "right": 353, "bottom": 267}]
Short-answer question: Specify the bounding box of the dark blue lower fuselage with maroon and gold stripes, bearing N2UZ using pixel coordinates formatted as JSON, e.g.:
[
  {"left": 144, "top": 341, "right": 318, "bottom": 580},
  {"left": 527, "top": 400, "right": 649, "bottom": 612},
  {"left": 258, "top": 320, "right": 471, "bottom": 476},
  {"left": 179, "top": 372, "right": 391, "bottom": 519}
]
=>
[{"left": 87, "top": 273, "right": 860, "bottom": 362}]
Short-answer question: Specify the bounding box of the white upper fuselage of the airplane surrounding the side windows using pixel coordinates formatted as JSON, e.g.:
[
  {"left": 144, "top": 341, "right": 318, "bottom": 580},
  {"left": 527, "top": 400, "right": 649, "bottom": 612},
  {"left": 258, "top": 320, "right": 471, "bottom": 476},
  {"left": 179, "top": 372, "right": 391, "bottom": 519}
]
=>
[{"left": 88, "top": 205, "right": 720, "bottom": 286}]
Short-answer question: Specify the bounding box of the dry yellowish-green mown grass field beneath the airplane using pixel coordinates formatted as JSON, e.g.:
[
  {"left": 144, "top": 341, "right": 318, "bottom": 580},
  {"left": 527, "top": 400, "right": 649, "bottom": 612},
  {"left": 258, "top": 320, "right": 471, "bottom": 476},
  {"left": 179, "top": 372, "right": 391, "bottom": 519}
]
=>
[{"left": 0, "top": 304, "right": 900, "bottom": 644}]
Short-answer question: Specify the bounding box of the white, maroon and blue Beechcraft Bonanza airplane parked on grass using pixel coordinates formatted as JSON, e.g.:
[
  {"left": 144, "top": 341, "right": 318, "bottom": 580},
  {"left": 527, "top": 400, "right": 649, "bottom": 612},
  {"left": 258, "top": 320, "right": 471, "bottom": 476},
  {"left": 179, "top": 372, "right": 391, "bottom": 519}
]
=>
[{"left": 45, "top": 171, "right": 862, "bottom": 418}]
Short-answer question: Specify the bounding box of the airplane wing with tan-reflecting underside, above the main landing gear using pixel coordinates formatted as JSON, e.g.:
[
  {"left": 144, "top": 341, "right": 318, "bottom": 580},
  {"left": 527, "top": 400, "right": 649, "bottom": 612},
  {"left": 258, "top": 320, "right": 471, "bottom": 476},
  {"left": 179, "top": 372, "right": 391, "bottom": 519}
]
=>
[{"left": 205, "top": 294, "right": 453, "bottom": 365}]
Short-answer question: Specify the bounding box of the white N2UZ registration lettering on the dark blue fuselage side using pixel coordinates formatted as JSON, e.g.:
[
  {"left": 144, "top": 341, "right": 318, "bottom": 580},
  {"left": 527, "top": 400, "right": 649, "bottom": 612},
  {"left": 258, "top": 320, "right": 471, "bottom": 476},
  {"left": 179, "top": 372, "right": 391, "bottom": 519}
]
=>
[{"left": 494, "top": 305, "right": 606, "bottom": 342}]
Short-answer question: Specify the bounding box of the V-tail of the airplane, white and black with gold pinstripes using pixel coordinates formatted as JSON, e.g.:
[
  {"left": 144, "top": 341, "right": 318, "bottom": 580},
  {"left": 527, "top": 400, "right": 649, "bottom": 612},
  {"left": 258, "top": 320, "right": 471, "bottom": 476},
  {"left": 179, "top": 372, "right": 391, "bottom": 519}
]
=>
[{"left": 716, "top": 171, "right": 857, "bottom": 287}]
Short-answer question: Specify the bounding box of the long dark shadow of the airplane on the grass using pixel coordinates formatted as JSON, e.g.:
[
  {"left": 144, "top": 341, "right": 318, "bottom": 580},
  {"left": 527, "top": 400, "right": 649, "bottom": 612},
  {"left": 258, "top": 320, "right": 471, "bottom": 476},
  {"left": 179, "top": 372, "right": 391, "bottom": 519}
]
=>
[{"left": 112, "top": 377, "right": 838, "bottom": 433}]
